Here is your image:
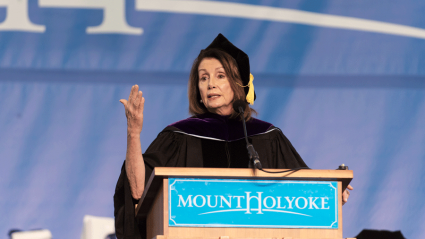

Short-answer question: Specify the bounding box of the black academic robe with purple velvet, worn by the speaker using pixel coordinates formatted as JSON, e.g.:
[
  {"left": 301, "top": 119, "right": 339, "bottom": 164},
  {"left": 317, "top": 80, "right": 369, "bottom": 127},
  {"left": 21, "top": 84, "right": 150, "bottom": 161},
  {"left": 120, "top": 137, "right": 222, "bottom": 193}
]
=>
[{"left": 114, "top": 113, "right": 307, "bottom": 239}]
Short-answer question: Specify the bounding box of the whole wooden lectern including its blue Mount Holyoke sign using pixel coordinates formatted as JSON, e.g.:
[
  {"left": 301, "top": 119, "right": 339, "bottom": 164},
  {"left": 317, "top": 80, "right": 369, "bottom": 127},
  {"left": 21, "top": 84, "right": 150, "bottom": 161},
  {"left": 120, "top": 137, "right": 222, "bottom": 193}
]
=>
[{"left": 136, "top": 167, "right": 353, "bottom": 239}]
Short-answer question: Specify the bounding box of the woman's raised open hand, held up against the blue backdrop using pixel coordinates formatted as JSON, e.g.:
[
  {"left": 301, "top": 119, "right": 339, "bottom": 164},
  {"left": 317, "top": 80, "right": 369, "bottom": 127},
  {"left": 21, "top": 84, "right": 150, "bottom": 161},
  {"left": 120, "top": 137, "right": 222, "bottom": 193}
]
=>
[{"left": 120, "top": 85, "right": 145, "bottom": 134}]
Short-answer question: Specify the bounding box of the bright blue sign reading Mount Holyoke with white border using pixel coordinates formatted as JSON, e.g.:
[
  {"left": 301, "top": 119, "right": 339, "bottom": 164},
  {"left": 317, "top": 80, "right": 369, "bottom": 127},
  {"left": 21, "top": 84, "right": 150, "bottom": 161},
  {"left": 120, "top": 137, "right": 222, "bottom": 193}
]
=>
[{"left": 168, "top": 178, "right": 338, "bottom": 229}]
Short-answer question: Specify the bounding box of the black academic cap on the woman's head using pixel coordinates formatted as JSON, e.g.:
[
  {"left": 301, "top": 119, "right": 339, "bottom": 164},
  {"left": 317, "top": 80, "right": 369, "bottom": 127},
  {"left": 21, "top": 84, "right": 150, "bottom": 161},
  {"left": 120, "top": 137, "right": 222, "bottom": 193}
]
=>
[{"left": 205, "top": 33, "right": 256, "bottom": 100}]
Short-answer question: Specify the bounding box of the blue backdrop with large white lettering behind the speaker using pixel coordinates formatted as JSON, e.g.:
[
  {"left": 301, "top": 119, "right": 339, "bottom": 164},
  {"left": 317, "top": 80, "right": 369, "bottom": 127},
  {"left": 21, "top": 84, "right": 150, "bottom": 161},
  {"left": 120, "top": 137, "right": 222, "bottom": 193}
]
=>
[{"left": 0, "top": 0, "right": 425, "bottom": 239}]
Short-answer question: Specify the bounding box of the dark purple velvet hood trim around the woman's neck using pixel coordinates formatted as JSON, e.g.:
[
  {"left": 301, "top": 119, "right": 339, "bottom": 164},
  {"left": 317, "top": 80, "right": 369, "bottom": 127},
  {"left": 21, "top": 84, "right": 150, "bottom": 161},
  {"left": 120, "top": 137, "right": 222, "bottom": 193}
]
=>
[{"left": 169, "top": 113, "right": 273, "bottom": 141}]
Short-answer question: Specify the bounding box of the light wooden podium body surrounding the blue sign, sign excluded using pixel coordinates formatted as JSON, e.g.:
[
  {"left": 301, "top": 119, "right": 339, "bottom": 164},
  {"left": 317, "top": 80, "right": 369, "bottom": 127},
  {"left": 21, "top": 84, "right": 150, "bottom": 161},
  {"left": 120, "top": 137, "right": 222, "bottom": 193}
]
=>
[{"left": 135, "top": 167, "right": 353, "bottom": 239}]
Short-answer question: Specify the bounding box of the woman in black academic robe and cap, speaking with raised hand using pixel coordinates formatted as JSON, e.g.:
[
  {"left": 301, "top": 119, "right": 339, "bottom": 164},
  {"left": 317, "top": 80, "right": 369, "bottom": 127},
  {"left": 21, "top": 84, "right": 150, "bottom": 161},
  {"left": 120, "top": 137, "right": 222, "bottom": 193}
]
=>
[{"left": 114, "top": 34, "right": 352, "bottom": 238}]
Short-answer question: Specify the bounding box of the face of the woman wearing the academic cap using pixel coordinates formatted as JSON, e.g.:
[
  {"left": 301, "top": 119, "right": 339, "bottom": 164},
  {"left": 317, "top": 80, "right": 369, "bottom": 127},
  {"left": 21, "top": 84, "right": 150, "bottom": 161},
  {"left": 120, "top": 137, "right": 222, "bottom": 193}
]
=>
[{"left": 198, "top": 58, "right": 234, "bottom": 115}]
